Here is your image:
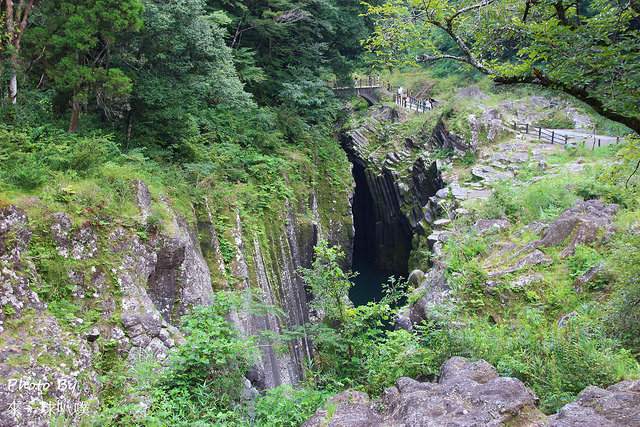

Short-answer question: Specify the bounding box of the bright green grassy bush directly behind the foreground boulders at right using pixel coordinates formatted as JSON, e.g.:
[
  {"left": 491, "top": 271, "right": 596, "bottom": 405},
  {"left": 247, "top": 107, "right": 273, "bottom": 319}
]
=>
[{"left": 449, "top": 309, "right": 638, "bottom": 413}]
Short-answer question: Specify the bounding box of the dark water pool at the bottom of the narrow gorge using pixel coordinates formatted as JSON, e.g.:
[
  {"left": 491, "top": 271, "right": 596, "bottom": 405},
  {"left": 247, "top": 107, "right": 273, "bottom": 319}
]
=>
[{"left": 349, "top": 251, "right": 398, "bottom": 306}]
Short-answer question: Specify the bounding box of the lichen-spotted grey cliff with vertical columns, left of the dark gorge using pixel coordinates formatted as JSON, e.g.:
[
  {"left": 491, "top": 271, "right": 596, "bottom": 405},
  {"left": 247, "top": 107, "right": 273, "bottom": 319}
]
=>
[{"left": 0, "top": 177, "right": 353, "bottom": 426}]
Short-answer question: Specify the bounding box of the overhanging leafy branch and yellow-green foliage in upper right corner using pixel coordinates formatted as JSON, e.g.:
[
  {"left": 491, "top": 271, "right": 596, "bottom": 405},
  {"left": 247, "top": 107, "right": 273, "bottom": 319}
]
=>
[{"left": 368, "top": 0, "right": 640, "bottom": 133}]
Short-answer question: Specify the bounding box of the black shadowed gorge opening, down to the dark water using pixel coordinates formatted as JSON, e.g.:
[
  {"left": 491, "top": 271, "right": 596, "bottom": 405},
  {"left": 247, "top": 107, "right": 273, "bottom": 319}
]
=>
[{"left": 349, "top": 162, "right": 411, "bottom": 306}]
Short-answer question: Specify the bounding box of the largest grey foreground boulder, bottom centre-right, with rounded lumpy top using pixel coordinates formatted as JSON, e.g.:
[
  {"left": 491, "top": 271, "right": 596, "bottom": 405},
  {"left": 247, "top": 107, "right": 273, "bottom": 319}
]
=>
[{"left": 304, "top": 357, "right": 546, "bottom": 427}]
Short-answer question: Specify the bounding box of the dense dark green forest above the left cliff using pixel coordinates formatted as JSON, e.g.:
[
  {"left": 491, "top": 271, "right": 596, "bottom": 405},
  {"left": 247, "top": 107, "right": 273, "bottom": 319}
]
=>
[{"left": 0, "top": 0, "right": 371, "bottom": 145}]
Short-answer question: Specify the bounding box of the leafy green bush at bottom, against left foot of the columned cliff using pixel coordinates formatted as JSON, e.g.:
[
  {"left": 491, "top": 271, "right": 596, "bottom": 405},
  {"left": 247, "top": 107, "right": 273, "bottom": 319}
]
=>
[{"left": 139, "top": 292, "right": 258, "bottom": 425}]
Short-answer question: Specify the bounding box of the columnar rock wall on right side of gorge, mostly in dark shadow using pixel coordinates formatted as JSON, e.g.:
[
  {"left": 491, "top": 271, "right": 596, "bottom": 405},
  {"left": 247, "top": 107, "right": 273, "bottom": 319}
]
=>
[{"left": 342, "top": 111, "right": 444, "bottom": 274}]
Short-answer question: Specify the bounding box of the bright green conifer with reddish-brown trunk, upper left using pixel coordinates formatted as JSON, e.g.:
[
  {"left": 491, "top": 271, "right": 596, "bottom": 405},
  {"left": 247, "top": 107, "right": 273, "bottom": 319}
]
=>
[{"left": 30, "top": 0, "right": 142, "bottom": 132}]
